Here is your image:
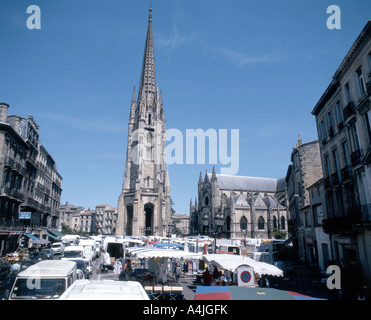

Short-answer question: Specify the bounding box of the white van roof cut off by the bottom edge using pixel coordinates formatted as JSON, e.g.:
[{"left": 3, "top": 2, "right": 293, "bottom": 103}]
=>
[{"left": 59, "top": 279, "right": 149, "bottom": 300}]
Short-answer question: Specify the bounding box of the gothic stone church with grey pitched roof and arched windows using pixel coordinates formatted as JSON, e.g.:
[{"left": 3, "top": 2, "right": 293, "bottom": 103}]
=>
[{"left": 190, "top": 168, "right": 289, "bottom": 239}]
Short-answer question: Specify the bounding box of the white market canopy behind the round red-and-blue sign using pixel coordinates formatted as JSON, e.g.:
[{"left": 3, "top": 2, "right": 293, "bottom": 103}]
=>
[{"left": 203, "top": 254, "right": 283, "bottom": 277}]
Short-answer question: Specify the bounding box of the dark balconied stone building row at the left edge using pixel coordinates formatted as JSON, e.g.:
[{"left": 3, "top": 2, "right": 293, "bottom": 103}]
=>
[{"left": 0, "top": 103, "right": 62, "bottom": 252}]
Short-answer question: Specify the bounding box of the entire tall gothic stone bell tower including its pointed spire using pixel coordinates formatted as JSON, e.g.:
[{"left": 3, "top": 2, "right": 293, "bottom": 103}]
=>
[{"left": 116, "top": 8, "right": 171, "bottom": 236}]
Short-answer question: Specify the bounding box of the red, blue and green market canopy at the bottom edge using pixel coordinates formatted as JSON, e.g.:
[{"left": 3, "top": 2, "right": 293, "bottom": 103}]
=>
[{"left": 195, "top": 286, "right": 323, "bottom": 300}]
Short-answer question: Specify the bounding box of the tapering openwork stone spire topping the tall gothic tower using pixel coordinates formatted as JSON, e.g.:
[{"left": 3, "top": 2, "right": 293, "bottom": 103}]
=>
[{"left": 138, "top": 7, "right": 157, "bottom": 102}]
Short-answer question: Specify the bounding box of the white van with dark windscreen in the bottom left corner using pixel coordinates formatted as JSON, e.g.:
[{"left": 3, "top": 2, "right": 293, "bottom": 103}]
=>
[{"left": 9, "top": 260, "right": 77, "bottom": 300}]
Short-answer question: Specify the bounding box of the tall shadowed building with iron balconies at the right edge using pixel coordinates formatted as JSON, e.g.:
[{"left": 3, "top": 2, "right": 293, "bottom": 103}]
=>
[{"left": 312, "top": 21, "right": 371, "bottom": 285}]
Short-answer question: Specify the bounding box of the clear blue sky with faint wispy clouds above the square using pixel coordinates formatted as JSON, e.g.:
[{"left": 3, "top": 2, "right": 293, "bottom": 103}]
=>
[{"left": 0, "top": 0, "right": 371, "bottom": 214}]
